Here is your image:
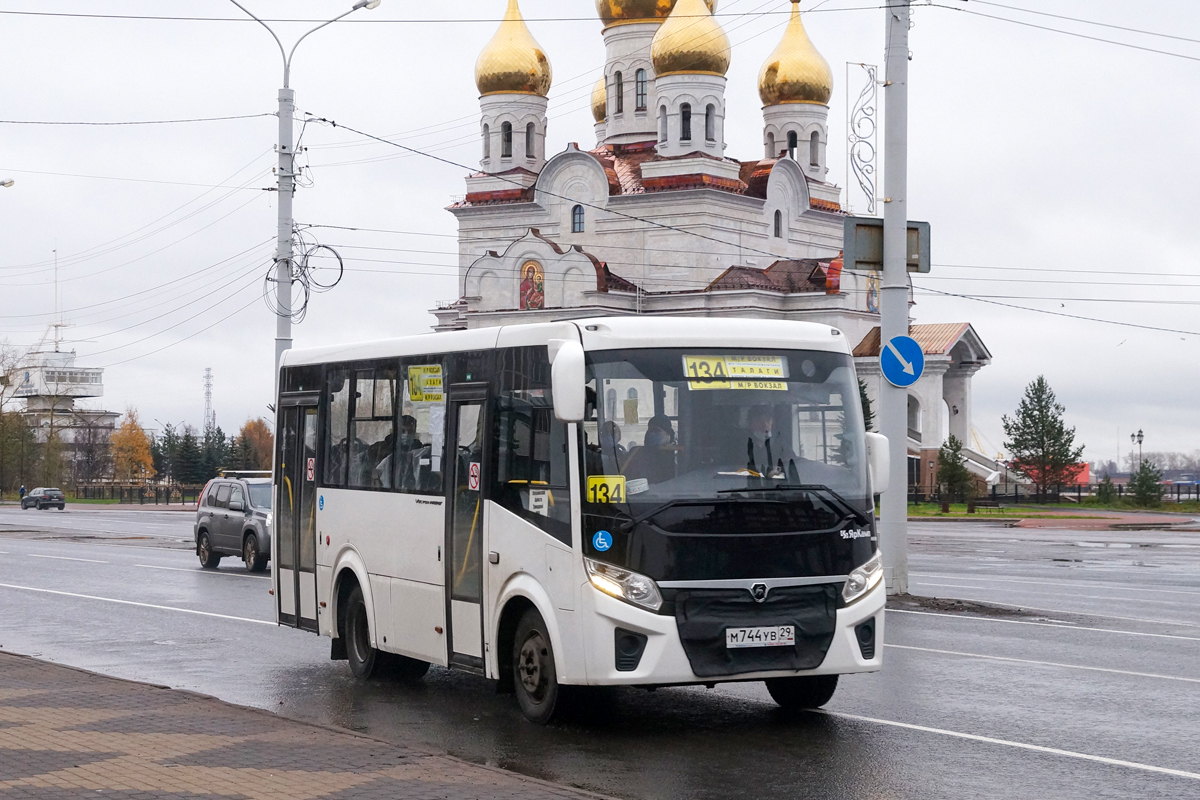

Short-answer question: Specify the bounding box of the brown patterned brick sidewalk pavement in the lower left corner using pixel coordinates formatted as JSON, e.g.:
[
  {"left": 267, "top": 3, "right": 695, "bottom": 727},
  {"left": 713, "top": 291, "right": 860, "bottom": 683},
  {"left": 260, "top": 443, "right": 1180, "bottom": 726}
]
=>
[{"left": 0, "top": 654, "right": 599, "bottom": 800}]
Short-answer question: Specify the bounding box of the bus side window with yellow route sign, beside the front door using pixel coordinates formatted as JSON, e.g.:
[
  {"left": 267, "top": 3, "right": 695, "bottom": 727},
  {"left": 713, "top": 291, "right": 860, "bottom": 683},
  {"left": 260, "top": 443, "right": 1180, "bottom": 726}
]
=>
[{"left": 391, "top": 359, "right": 446, "bottom": 494}]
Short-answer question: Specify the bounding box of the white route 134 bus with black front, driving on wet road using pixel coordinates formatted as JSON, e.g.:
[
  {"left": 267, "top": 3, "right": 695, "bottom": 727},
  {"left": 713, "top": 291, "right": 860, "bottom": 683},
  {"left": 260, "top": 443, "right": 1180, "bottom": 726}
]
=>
[{"left": 271, "top": 317, "right": 888, "bottom": 722}]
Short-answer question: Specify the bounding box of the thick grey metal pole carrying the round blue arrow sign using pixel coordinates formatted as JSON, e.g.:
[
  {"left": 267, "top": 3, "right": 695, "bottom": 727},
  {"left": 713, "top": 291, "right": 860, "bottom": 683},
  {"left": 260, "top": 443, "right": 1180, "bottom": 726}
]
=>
[{"left": 880, "top": 0, "right": 911, "bottom": 595}]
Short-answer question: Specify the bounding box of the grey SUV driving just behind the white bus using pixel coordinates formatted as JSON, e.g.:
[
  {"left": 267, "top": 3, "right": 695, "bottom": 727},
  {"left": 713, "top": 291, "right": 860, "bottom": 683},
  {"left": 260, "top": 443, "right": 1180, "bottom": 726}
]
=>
[{"left": 196, "top": 477, "right": 271, "bottom": 572}]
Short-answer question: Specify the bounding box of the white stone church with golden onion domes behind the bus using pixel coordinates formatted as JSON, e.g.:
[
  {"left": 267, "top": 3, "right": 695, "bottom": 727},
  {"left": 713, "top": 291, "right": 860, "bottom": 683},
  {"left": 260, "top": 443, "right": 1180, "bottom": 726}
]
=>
[{"left": 432, "top": 0, "right": 997, "bottom": 494}]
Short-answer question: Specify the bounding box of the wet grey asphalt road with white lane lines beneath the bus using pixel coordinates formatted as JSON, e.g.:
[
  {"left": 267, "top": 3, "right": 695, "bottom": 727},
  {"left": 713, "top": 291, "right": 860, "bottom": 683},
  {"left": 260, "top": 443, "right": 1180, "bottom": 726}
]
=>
[{"left": 0, "top": 507, "right": 1200, "bottom": 799}]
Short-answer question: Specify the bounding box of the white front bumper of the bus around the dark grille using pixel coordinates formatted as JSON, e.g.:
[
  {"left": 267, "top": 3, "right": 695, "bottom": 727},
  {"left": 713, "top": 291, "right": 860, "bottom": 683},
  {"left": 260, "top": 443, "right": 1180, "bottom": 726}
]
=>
[{"left": 580, "top": 581, "right": 887, "bottom": 686}]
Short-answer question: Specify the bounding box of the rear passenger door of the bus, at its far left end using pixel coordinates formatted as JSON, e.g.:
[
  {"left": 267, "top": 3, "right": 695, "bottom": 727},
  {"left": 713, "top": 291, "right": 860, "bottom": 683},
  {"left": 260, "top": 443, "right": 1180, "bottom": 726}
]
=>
[{"left": 271, "top": 397, "right": 318, "bottom": 631}]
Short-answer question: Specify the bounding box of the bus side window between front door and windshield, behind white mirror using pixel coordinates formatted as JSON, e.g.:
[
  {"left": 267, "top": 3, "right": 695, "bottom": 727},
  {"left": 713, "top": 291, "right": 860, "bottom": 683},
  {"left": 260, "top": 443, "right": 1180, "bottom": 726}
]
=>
[{"left": 492, "top": 347, "right": 571, "bottom": 545}]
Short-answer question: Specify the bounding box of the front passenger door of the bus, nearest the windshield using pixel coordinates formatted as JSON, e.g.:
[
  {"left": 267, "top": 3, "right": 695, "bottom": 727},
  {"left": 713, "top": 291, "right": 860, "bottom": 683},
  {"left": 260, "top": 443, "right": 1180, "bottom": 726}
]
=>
[{"left": 446, "top": 384, "right": 488, "bottom": 670}]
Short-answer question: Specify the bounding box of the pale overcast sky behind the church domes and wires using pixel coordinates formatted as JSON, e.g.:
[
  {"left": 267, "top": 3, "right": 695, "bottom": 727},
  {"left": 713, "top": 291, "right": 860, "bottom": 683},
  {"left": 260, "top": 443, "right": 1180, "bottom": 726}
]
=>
[{"left": 0, "top": 0, "right": 1200, "bottom": 459}]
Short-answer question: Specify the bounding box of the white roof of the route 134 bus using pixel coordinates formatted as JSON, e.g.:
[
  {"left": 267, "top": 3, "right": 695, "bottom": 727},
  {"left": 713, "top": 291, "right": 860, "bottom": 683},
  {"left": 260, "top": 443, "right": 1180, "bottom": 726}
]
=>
[{"left": 283, "top": 315, "right": 850, "bottom": 366}]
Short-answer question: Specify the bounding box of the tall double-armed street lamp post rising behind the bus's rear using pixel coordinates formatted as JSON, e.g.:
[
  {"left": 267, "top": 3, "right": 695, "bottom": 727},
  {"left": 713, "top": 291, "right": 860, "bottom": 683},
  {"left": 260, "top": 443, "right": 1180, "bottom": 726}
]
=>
[{"left": 229, "top": 0, "right": 382, "bottom": 395}]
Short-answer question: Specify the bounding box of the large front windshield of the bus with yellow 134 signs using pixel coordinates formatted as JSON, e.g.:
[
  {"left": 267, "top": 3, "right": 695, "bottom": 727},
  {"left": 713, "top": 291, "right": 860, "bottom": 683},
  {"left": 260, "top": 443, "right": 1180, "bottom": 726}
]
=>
[{"left": 583, "top": 348, "right": 869, "bottom": 533}]
